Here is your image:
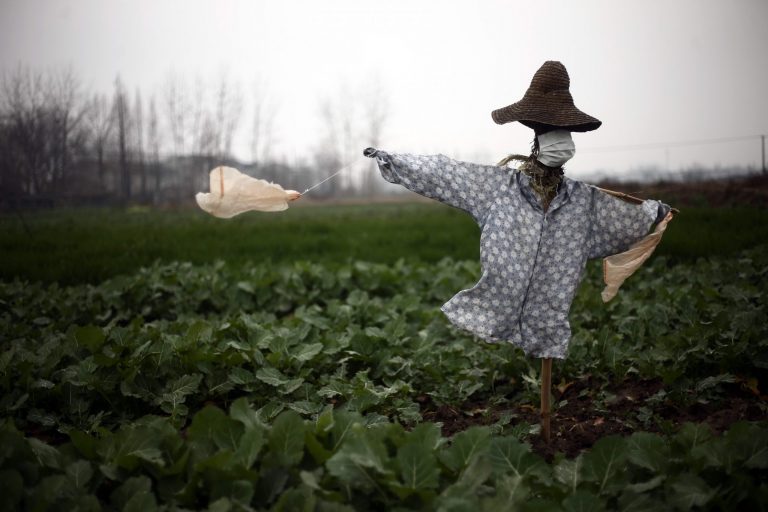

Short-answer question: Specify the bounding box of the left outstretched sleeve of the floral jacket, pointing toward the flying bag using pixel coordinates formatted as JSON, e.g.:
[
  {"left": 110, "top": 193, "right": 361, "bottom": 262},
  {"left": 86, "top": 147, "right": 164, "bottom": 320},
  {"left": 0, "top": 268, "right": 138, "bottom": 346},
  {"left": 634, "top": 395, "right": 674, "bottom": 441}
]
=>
[{"left": 376, "top": 151, "right": 509, "bottom": 224}]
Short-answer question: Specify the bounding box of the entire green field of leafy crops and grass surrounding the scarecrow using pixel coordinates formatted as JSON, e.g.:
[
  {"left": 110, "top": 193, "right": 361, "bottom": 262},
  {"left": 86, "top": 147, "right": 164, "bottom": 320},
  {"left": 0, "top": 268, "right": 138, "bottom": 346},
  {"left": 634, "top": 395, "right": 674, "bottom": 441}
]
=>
[{"left": 0, "top": 203, "right": 768, "bottom": 511}]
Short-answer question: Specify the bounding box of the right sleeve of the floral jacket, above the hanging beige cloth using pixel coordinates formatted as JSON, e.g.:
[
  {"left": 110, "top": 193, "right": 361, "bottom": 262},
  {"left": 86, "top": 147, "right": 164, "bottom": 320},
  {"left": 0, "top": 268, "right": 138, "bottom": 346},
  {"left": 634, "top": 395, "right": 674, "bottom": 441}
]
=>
[{"left": 589, "top": 187, "right": 670, "bottom": 258}]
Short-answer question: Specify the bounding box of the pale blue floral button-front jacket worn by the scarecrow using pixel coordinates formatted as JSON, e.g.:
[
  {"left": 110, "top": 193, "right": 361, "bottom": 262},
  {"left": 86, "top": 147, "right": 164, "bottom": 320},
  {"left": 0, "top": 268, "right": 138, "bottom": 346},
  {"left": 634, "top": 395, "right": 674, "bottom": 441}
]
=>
[{"left": 375, "top": 151, "right": 669, "bottom": 359}]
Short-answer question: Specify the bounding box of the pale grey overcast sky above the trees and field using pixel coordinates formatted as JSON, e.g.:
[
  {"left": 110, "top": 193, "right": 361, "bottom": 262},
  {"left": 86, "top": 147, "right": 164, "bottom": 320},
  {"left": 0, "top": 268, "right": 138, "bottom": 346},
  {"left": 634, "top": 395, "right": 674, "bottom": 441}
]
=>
[{"left": 0, "top": 0, "right": 768, "bottom": 176}]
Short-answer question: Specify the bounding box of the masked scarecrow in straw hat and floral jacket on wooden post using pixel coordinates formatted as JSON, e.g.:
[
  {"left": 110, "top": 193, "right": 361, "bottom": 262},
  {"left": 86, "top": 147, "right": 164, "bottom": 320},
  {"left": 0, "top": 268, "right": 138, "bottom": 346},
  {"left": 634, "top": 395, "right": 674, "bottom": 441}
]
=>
[{"left": 363, "top": 61, "right": 672, "bottom": 441}]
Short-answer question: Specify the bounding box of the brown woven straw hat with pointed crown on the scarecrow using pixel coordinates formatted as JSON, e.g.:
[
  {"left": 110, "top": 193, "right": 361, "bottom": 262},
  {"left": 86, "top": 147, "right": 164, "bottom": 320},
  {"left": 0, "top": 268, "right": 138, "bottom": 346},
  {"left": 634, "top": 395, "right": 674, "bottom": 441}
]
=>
[{"left": 491, "top": 60, "right": 602, "bottom": 132}]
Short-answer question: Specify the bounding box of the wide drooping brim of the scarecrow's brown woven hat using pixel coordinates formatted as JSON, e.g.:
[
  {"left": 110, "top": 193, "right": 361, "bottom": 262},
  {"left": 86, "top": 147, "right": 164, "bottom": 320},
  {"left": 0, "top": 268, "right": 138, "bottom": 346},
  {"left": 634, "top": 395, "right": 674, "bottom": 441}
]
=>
[{"left": 491, "top": 100, "right": 603, "bottom": 132}]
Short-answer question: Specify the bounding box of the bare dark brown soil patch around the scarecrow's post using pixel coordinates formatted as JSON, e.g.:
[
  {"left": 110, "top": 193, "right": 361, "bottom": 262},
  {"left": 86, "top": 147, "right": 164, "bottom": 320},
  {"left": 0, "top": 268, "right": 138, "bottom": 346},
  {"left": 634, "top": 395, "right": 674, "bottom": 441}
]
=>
[{"left": 422, "top": 379, "right": 766, "bottom": 462}]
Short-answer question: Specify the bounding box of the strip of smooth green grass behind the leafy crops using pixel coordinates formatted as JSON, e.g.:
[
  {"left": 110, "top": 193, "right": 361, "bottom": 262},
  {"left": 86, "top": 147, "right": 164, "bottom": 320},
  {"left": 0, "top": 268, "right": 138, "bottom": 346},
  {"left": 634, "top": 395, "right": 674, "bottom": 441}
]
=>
[{"left": 0, "top": 202, "right": 768, "bottom": 284}]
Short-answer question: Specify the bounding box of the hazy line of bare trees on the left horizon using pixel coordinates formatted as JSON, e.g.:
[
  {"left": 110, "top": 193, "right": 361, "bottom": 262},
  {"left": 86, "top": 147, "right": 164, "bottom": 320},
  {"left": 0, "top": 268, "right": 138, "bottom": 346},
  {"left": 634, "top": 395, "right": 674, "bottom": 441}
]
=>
[{"left": 0, "top": 65, "right": 388, "bottom": 208}]
